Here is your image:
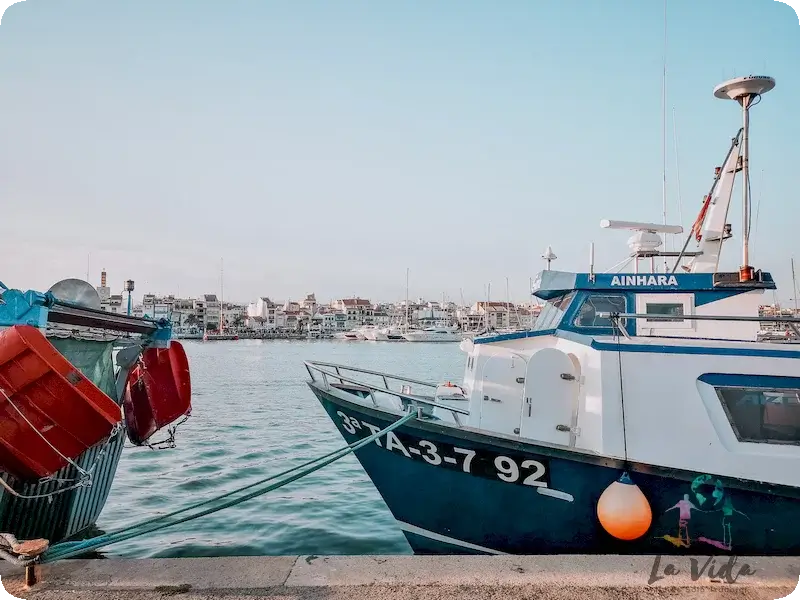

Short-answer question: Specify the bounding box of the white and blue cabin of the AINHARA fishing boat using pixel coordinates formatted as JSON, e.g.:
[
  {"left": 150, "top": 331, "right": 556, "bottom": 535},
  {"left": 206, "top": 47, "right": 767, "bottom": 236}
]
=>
[{"left": 450, "top": 271, "right": 800, "bottom": 490}]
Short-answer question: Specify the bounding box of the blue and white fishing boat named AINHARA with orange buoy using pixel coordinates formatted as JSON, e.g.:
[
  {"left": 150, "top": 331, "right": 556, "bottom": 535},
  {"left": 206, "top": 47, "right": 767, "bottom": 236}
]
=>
[{"left": 306, "top": 76, "right": 800, "bottom": 555}]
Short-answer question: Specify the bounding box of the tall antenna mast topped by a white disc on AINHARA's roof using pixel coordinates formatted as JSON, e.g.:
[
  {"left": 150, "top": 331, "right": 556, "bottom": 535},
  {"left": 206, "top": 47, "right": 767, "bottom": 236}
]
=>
[{"left": 714, "top": 75, "right": 775, "bottom": 281}]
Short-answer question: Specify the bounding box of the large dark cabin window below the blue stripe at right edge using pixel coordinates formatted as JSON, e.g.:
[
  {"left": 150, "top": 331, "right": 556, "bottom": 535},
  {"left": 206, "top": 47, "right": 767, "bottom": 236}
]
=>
[{"left": 717, "top": 387, "right": 800, "bottom": 444}]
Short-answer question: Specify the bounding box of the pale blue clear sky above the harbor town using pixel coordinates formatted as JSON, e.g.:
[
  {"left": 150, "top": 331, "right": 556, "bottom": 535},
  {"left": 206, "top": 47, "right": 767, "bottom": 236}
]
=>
[{"left": 0, "top": 0, "right": 800, "bottom": 302}]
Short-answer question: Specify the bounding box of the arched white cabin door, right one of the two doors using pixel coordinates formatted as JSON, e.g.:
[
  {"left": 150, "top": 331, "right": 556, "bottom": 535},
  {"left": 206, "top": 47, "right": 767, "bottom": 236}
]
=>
[{"left": 520, "top": 348, "right": 581, "bottom": 446}]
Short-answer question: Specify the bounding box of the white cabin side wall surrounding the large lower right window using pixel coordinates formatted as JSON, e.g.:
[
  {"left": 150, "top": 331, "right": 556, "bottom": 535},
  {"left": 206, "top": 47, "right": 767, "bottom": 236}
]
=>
[{"left": 620, "top": 351, "right": 800, "bottom": 486}]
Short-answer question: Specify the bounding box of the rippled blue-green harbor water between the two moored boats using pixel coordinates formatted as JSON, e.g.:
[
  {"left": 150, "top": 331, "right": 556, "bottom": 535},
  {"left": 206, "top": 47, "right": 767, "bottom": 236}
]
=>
[{"left": 98, "top": 340, "right": 464, "bottom": 558}]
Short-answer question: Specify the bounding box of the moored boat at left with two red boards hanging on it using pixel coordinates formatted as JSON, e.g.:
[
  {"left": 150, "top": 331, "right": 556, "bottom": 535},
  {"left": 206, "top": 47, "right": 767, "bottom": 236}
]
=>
[{"left": 0, "top": 279, "right": 191, "bottom": 548}]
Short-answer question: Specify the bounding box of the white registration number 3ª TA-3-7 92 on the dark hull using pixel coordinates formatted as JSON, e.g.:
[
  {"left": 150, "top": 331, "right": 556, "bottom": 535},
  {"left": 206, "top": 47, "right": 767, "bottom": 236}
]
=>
[{"left": 336, "top": 410, "right": 550, "bottom": 488}]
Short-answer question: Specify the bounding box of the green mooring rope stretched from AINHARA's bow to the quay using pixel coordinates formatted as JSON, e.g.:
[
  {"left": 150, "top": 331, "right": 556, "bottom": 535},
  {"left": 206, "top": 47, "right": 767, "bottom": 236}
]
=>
[{"left": 42, "top": 413, "right": 416, "bottom": 563}]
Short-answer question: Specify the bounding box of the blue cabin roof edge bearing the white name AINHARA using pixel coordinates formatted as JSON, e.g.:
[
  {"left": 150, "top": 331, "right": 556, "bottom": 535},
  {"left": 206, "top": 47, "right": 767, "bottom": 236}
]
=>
[{"left": 531, "top": 271, "right": 776, "bottom": 300}]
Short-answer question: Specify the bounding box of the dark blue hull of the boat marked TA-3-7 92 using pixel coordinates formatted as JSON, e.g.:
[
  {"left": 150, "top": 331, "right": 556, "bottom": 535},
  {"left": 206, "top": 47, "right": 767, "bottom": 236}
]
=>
[{"left": 310, "top": 384, "right": 800, "bottom": 556}]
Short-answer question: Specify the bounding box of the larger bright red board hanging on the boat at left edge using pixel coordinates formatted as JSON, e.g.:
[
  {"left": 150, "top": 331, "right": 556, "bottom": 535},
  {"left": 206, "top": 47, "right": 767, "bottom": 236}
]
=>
[{"left": 0, "top": 325, "right": 122, "bottom": 480}]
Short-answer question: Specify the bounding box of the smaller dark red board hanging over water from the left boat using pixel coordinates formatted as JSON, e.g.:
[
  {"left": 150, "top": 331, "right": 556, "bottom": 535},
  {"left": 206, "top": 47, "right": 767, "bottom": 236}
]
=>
[{"left": 122, "top": 341, "right": 192, "bottom": 446}]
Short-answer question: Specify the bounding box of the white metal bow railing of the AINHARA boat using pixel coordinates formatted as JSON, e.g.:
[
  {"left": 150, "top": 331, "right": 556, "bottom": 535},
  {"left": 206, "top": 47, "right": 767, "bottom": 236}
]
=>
[{"left": 305, "top": 360, "right": 469, "bottom": 426}]
